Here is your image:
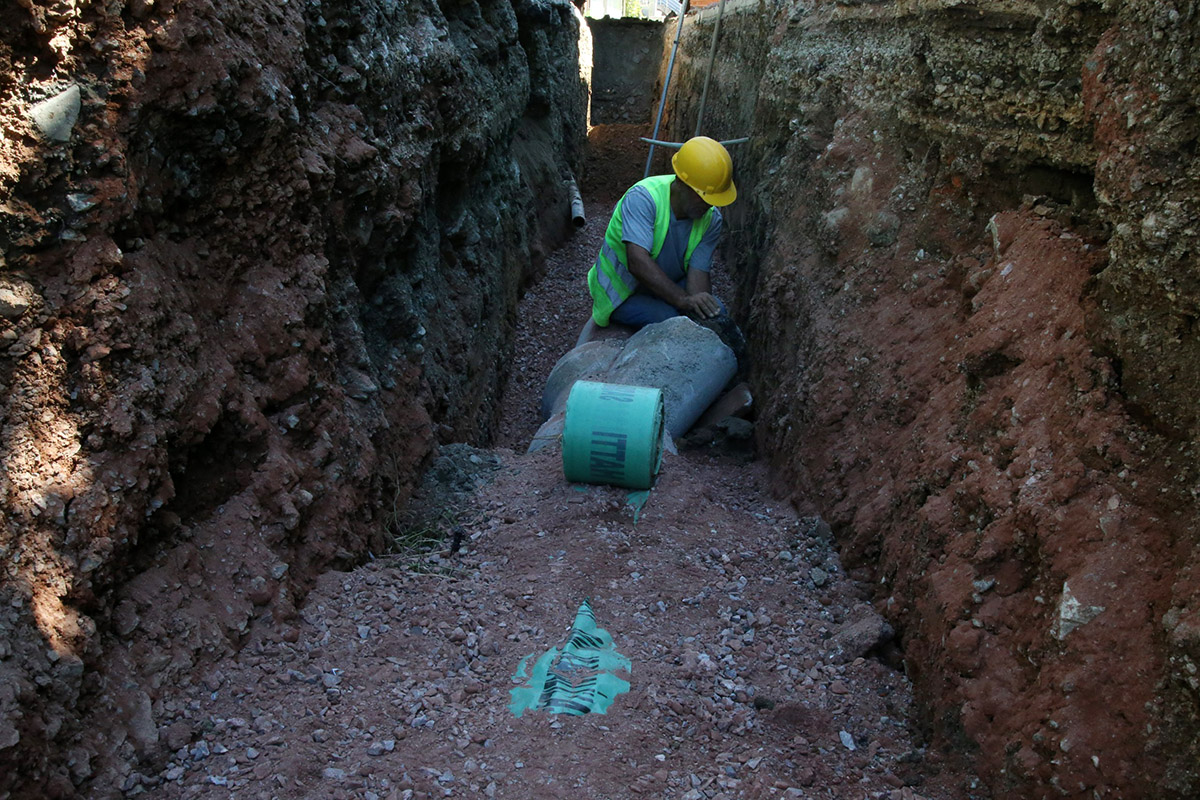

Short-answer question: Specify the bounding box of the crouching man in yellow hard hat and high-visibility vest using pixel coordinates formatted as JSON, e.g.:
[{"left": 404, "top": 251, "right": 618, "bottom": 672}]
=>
[{"left": 588, "top": 137, "right": 738, "bottom": 327}]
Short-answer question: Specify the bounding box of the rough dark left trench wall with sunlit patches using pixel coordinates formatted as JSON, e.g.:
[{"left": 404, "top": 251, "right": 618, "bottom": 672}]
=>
[{"left": 0, "top": 0, "right": 588, "bottom": 798}]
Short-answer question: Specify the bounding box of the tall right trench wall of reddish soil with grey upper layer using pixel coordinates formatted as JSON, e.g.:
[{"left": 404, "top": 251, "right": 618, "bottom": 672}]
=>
[{"left": 664, "top": 0, "right": 1200, "bottom": 798}]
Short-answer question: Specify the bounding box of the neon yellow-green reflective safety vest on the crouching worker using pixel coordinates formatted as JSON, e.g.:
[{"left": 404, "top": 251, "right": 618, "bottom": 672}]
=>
[{"left": 588, "top": 175, "right": 713, "bottom": 326}]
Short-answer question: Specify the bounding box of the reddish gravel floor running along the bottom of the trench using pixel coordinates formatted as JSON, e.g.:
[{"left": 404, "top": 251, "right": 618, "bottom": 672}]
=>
[{"left": 121, "top": 126, "right": 979, "bottom": 800}]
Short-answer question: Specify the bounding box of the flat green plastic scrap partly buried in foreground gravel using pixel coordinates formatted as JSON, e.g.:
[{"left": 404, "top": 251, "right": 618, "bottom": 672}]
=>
[{"left": 509, "top": 600, "right": 631, "bottom": 716}]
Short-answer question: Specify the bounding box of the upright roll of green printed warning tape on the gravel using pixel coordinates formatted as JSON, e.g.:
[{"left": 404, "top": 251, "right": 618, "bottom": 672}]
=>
[{"left": 563, "top": 380, "right": 662, "bottom": 489}]
